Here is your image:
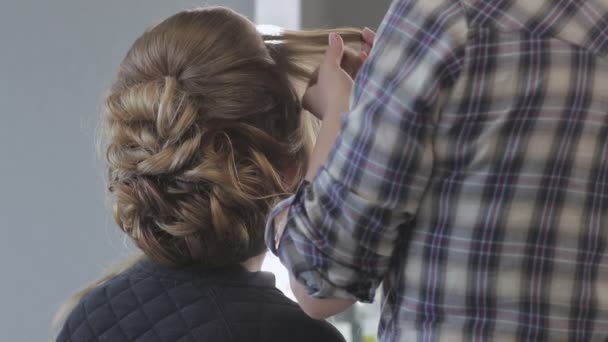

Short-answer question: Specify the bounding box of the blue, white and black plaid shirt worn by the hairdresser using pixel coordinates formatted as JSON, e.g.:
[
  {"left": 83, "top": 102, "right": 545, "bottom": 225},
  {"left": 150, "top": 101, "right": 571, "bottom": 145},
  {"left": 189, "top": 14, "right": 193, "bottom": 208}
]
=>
[{"left": 267, "top": 0, "right": 608, "bottom": 341}]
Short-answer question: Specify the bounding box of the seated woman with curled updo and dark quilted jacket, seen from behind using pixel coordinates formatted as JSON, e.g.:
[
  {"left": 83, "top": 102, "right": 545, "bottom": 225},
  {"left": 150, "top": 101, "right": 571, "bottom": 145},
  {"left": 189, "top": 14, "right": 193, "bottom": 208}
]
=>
[{"left": 55, "top": 7, "right": 365, "bottom": 342}]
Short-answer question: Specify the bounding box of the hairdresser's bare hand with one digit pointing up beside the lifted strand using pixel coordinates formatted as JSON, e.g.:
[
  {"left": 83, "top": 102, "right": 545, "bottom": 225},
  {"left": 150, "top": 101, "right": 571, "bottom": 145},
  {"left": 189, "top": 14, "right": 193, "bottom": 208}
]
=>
[{"left": 302, "top": 33, "right": 353, "bottom": 120}]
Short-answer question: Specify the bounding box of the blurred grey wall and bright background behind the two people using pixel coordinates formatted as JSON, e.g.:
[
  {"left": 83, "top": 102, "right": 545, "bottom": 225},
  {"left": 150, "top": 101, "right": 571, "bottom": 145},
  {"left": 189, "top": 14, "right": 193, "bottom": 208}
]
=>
[{"left": 0, "top": 0, "right": 390, "bottom": 342}]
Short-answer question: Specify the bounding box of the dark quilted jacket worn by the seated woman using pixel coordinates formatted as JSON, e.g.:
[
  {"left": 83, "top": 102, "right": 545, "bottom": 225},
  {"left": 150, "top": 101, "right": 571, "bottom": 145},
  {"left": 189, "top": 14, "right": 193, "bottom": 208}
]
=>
[{"left": 57, "top": 260, "right": 344, "bottom": 342}]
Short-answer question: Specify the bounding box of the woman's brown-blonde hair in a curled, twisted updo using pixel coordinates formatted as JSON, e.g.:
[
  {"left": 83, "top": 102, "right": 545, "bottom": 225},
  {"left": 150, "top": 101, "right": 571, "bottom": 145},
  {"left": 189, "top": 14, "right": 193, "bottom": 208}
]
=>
[{"left": 53, "top": 7, "right": 361, "bottom": 334}]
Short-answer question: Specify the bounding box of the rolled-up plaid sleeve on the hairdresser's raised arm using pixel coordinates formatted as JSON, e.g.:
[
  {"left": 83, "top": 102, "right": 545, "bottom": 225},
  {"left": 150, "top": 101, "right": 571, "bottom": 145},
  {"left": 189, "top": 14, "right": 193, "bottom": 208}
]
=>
[{"left": 267, "top": 0, "right": 467, "bottom": 302}]
